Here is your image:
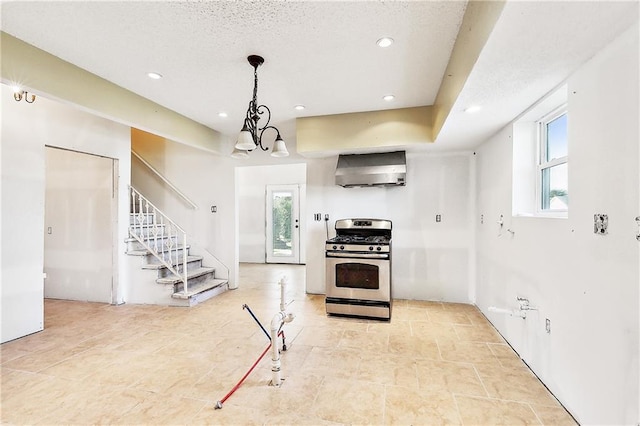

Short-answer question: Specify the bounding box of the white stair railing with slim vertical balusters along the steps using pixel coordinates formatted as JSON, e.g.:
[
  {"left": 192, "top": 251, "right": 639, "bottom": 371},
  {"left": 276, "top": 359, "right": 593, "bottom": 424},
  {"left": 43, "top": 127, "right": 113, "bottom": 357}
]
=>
[{"left": 129, "top": 186, "right": 188, "bottom": 293}]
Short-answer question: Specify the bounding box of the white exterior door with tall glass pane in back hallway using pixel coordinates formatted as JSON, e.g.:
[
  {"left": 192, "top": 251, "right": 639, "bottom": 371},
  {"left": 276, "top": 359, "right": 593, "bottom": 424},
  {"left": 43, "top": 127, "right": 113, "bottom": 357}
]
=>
[{"left": 266, "top": 185, "right": 300, "bottom": 264}]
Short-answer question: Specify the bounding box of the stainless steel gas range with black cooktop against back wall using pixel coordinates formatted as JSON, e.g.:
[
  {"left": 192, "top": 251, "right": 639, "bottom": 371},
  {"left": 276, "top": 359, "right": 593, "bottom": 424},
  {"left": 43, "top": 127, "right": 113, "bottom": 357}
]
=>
[{"left": 325, "top": 219, "right": 391, "bottom": 320}]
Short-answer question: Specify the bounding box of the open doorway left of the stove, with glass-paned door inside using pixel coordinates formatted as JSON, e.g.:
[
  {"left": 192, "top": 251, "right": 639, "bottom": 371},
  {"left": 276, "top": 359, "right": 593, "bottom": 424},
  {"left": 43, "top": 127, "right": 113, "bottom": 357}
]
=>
[{"left": 236, "top": 163, "right": 307, "bottom": 264}]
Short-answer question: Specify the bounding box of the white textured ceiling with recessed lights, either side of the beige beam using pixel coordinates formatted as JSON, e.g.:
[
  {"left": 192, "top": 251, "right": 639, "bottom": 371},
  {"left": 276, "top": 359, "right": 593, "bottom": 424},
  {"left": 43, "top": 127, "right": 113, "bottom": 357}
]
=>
[{"left": 1, "top": 0, "right": 638, "bottom": 156}]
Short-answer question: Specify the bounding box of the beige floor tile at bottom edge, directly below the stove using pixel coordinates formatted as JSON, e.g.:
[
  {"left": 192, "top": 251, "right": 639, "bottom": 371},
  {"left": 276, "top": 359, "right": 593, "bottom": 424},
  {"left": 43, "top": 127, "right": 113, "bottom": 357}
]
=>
[{"left": 312, "top": 377, "right": 385, "bottom": 425}]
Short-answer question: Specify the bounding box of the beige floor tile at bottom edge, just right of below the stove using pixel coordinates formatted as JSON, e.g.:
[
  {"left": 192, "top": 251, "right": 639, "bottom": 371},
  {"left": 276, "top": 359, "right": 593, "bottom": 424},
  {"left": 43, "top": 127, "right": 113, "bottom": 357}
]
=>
[{"left": 384, "top": 386, "right": 461, "bottom": 425}]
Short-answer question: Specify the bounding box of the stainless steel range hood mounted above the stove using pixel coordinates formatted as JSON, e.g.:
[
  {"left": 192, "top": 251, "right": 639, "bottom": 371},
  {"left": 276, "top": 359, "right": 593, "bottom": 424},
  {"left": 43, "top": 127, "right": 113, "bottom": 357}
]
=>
[{"left": 336, "top": 151, "right": 407, "bottom": 188}]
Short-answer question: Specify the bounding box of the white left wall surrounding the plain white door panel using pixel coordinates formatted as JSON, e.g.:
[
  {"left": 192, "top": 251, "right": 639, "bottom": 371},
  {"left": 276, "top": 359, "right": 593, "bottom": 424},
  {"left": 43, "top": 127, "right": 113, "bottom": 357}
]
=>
[{"left": 0, "top": 84, "right": 131, "bottom": 342}]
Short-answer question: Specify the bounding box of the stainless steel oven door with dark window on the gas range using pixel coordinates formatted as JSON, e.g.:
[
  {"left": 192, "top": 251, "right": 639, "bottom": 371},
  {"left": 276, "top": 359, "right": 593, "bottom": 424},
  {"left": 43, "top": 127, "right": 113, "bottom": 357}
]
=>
[{"left": 326, "top": 256, "right": 391, "bottom": 302}]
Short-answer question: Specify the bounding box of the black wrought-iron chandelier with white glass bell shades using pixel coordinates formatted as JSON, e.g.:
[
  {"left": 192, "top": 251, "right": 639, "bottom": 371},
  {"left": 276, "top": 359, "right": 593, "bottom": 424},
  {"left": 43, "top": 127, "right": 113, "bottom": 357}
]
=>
[{"left": 231, "top": 55, "right": 289, "bottom": 158}]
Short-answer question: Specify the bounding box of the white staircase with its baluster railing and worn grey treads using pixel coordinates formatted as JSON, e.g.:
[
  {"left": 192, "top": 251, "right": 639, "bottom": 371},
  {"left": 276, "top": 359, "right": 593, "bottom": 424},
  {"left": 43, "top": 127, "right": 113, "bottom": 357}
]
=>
[{"left": 126, "top": 187, "right": 229, "bottom": 306}]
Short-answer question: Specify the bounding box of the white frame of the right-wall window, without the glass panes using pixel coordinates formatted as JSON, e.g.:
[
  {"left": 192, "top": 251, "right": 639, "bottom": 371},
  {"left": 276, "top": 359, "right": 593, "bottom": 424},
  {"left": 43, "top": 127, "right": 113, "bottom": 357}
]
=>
[{"left": 536, "top": 104, "right": 569, "bottom": 217}]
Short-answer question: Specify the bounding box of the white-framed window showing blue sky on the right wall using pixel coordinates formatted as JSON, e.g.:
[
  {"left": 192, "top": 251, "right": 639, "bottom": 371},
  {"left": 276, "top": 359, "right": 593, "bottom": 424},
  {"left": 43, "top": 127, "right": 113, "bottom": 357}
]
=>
[{"left": 537, "top": 106, "right": 569, "bottom": 213}]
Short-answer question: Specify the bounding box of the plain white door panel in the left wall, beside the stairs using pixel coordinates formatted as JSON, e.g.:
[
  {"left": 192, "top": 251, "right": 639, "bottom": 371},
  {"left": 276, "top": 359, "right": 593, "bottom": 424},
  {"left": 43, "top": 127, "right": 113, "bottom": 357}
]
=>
[{"left": 44, "top": 147, "right": 116, "bottom": 303}]
